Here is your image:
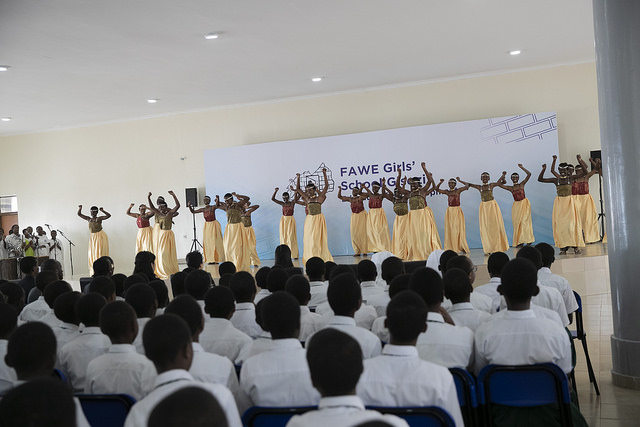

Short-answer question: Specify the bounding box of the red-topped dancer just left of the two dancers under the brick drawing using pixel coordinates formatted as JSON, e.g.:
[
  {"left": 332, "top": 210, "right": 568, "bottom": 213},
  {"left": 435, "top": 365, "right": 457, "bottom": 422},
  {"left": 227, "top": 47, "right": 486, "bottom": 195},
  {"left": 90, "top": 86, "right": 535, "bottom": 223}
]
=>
[{"left": 435, "top": 178, "right": 469, "bottom": 254}]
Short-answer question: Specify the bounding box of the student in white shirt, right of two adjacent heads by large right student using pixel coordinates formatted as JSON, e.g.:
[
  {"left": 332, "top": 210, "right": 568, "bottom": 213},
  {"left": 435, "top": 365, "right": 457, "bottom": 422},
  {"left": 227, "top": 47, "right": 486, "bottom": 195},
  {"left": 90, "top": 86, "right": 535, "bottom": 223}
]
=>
[{"left": 442, "top": 268, "right": 491, "bottom": 331}]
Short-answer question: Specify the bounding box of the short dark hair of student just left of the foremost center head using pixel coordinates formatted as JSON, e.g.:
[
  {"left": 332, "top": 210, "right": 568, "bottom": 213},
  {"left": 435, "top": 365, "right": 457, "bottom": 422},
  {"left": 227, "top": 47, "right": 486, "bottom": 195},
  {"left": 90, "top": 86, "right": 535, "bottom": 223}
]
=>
[{"left": 260, "top": 291, "right": 300, "bottom": 339}]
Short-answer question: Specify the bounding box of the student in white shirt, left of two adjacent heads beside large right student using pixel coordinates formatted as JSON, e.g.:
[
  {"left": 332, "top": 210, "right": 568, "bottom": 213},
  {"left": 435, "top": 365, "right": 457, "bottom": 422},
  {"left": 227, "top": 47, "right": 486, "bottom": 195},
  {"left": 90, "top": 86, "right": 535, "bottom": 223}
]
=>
[{"left": 409, "top": 267, "right": 473, "bottom": 368}]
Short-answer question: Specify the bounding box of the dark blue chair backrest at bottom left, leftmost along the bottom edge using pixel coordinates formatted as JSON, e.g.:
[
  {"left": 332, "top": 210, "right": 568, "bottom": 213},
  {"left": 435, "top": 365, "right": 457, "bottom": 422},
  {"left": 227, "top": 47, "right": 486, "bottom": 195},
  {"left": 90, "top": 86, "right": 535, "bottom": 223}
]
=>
[{"left": 76, "top": 394, "right": 136, "bottom": 427}]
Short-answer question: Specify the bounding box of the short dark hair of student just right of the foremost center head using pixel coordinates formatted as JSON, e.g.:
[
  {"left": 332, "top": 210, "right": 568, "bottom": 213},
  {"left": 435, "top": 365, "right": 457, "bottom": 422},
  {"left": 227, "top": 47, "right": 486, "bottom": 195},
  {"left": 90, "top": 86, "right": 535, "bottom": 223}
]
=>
[{"left": 386, "top": 290, "right": 428, "bottom": 343}]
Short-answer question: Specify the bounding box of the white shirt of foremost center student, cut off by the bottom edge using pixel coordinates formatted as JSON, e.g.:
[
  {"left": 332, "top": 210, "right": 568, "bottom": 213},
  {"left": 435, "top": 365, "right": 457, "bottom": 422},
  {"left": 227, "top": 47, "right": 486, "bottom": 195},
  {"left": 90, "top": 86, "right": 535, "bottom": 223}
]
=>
[{"left": 286, "top": 396, "right": 409, "bottom": 427}]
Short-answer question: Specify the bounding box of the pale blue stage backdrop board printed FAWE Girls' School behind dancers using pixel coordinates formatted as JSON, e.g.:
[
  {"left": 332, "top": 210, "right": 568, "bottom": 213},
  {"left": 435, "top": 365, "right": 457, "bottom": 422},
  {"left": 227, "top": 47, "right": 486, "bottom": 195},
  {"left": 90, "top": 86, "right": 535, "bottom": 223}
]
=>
[{"left": 204, "top": 112, "right": 560, "bottom": 259}]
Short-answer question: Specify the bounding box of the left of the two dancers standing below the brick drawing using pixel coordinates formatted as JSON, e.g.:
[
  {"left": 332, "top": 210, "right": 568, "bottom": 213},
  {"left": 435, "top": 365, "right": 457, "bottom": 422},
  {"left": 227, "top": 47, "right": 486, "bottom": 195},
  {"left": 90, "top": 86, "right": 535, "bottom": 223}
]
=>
[{"left": 456, "top": 171, "right": 509, "bottom": 255}]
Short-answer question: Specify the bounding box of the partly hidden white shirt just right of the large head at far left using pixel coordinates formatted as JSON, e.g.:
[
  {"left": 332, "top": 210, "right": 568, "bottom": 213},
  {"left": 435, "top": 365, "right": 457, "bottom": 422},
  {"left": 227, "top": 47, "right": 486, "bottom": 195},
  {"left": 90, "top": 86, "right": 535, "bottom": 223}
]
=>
[{"left": 58, "top": 326, "right": 111, "bottom": 392}]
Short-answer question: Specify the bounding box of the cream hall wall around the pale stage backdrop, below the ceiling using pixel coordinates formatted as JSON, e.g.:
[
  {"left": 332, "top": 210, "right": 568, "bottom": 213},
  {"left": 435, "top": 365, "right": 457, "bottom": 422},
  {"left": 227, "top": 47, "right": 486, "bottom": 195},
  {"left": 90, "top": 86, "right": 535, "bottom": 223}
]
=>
[{"left": 0, "top": 63, "right": 600, "bottom": 275}]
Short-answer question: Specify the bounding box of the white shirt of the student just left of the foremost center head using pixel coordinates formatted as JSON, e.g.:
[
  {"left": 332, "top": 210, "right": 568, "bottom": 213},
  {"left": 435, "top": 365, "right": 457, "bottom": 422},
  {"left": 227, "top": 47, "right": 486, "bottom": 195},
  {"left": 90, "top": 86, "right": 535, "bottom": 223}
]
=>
[{"left": 240, "top": 338, "right": 320, "bottom": 406}]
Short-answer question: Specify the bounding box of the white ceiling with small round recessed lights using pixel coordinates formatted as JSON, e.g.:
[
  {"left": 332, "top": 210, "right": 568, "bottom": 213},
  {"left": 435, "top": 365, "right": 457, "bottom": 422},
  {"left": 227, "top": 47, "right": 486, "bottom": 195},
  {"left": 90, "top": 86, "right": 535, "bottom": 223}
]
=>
[{"left": 0, "top": 0, "right": 595, "bottom": 135}]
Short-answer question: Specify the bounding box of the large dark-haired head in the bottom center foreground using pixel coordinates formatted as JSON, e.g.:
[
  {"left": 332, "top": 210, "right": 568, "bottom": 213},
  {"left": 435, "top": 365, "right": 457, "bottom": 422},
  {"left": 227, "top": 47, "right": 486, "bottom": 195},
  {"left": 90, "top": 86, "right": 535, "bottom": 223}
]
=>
[{"left": 307, "top": 328, "right": 363, "bottom": 397}]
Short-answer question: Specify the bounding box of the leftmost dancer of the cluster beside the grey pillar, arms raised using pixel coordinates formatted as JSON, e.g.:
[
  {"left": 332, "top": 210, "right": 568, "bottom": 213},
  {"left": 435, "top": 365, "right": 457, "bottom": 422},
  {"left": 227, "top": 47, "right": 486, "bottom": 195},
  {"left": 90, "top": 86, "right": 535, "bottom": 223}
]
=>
[{"left": 538, "top": 155, "right": 584, "bottom": 255}]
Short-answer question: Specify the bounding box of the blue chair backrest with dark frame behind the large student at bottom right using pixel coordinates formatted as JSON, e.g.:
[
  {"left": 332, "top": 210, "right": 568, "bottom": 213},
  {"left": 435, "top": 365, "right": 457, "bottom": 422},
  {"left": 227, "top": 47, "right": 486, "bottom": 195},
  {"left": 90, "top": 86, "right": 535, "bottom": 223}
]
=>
[{"left": 478, "top": 363, "right": 572, "bottom": 426}]
